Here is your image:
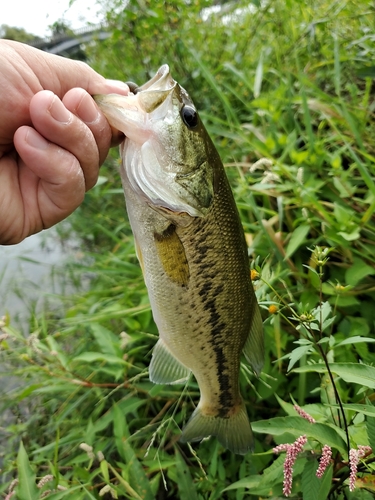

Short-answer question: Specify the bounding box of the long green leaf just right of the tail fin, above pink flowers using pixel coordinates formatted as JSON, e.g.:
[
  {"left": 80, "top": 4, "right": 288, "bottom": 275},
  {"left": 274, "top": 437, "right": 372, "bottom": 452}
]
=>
[{"left": 251, "top": 417, "right": 346, "bottom": 453}]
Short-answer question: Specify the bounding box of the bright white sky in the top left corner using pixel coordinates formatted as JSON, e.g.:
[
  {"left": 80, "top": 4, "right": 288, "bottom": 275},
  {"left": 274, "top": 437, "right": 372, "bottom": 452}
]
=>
[{"left": 0, "top": 0, "right": 101, "bottom": 38}]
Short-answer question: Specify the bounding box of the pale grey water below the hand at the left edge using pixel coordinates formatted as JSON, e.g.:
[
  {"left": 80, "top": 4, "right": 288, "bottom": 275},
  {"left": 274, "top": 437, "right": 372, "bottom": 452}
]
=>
[{"left": 0, "top": 227, "right": 87, "bottom": 472}]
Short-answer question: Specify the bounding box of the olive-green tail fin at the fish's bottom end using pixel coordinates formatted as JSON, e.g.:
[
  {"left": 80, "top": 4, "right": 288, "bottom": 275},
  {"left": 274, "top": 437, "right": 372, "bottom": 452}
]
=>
[{"left": 180, "top": 402, "right": 254, "bottom": 455}]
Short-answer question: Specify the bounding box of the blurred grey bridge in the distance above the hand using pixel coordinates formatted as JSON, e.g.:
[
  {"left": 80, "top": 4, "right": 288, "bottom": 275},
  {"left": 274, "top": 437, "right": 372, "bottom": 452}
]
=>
[{"left": 29, "top": 23, "right": 112, "bottom": 56}]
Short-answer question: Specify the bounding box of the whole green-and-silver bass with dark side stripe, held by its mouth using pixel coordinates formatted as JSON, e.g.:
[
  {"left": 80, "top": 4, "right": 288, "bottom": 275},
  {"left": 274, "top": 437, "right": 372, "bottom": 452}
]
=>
[{"left": 94, "top": 64, "right": 264, "bottom": 454}]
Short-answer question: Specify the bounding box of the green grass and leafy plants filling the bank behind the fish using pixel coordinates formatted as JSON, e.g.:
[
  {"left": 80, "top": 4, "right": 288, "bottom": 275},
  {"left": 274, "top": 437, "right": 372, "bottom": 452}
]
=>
[{"left": 0, "top": 0, "right": 375, "bottom": 500}]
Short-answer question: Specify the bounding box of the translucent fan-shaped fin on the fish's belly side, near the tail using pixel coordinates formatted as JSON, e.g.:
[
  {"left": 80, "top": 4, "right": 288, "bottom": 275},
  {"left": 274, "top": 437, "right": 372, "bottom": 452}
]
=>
[{"left": 149, "top": 339, "right": 190, "bottom": 384}]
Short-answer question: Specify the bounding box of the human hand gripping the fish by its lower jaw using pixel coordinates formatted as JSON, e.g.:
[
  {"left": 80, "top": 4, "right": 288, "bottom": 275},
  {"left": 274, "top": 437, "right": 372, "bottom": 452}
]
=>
[{"left": 0, "top": 40, "right": 128, "bottom": 245}]
